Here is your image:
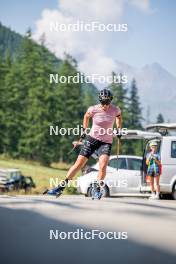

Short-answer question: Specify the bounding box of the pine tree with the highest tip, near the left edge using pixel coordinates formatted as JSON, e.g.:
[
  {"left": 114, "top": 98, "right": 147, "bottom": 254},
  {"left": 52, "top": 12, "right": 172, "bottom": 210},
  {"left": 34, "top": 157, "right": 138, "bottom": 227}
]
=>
[{"left": 5, "top": 30, "right": 34, "bottom": 157}]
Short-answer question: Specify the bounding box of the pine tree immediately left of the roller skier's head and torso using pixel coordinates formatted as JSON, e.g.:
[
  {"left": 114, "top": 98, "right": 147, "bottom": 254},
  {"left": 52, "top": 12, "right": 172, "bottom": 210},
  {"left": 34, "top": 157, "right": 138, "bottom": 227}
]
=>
[{"left": 56, "top": 55, "right": 83, "bottom": 161}]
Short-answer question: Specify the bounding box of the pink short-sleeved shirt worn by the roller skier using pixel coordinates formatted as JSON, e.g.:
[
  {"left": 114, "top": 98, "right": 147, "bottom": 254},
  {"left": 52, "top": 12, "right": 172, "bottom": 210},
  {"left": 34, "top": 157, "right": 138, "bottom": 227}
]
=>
[{"left": 87, "top": 104, "right": 121, "bottom": 144}]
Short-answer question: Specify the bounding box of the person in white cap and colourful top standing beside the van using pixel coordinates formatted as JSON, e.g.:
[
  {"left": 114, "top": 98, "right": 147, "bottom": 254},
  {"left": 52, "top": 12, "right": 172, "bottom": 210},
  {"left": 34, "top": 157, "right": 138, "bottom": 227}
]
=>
[{"left": 146, "top": 141, "right": 161, "bottom": 200}]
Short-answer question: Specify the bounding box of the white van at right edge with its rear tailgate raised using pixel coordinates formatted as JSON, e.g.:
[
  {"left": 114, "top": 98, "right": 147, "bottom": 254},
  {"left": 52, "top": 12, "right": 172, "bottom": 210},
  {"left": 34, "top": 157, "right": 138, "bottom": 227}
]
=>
[{"left": 123, "top": 123, "right": 176, "bottom": 200}]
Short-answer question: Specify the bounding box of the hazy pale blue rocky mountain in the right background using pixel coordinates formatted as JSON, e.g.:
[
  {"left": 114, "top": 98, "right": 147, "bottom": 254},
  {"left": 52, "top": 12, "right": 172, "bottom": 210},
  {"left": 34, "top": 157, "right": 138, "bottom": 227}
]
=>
[{"left": 116, "top": 61, "right": 176, "bottom": 122}]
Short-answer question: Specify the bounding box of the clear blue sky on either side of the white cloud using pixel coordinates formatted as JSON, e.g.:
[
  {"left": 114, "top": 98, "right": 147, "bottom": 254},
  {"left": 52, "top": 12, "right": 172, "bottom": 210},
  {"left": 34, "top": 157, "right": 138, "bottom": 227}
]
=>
[{"left": 0, "top": 0, "right": 176, "bottom": 76}]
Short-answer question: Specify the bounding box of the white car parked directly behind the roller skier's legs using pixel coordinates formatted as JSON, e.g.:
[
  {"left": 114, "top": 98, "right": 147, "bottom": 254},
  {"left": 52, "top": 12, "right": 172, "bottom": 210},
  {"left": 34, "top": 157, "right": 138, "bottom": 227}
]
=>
[{"left": 78, "top": 155, "right": 142, "bottom": 196}]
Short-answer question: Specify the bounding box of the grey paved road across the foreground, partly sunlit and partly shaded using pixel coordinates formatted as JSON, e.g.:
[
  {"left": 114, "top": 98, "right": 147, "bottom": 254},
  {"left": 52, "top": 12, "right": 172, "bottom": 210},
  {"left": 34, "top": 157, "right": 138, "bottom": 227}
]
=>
[{"left": 0, "top": 196, "right": 176, "bottom": 264}]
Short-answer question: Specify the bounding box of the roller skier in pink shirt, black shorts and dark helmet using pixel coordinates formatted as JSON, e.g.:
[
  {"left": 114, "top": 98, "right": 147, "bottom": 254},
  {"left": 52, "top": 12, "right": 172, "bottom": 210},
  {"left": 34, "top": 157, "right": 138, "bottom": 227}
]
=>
[{"left": 44, "top": 89, "right": 122, "bottom": 199}]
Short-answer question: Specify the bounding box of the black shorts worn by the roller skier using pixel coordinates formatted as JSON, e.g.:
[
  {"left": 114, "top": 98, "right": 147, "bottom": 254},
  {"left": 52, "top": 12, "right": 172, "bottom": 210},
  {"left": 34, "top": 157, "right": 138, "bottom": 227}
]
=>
[{"left": 79, "top": 136, "right": 112, "bottom": 158}]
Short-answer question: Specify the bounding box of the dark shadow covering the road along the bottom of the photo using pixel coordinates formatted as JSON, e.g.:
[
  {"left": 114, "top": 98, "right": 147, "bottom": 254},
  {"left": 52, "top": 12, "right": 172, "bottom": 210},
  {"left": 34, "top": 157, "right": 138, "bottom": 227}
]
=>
[{"left": 0, "top": 207, "right": 175, "bottom": 264}]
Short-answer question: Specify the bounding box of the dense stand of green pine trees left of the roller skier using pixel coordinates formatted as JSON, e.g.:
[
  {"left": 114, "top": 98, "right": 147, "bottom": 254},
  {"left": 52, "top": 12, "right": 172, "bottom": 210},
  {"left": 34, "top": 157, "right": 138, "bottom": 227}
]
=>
[{"left": 0, "top": 25, "right": 99, "bottom": 165}]
